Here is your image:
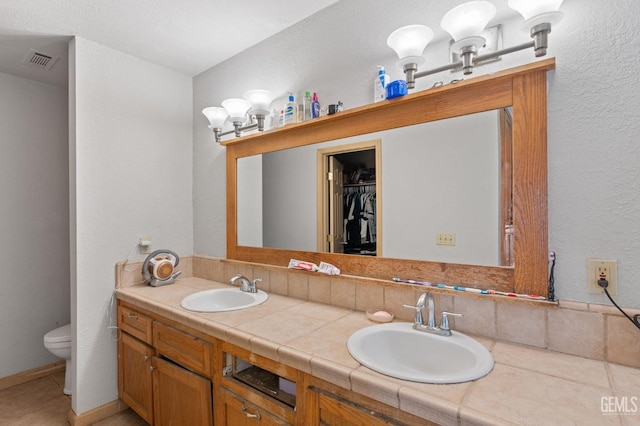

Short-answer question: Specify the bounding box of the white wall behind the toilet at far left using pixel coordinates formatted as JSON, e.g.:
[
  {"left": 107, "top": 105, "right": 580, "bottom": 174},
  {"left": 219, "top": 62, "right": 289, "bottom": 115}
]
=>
[{"left": 0, "top": 73, "right": 70, "bottom": 377}]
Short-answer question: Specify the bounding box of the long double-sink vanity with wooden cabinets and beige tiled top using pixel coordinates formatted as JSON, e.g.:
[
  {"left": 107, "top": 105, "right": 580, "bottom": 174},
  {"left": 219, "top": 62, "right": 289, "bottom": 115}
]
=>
[{"left": 116, "top": 270, "right": 640, "bottom": 426}]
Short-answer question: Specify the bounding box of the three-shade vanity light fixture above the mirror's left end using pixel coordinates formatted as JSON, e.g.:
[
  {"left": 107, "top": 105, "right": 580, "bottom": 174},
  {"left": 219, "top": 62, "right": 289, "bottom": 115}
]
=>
[{"left": 202, "top": 89, "right": 275, "bottom": 143}]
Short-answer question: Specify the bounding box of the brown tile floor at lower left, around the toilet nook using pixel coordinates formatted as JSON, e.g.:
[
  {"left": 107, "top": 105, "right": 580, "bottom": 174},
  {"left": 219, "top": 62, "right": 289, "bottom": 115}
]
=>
[{"left": 0, "top": 372, "right": 147, "bottom": 426}]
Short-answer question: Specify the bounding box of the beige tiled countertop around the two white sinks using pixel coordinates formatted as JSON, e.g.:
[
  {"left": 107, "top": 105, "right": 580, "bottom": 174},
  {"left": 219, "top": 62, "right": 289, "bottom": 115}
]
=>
[{"left": 117, "top": 277, "right": 640, "bottom": 425}]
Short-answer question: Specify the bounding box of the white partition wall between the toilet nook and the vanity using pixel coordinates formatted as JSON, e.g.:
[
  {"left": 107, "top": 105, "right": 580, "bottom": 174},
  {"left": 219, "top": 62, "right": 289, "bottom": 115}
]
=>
[{"left": 70, "top": 38, "right": 193, "bottom": 414}]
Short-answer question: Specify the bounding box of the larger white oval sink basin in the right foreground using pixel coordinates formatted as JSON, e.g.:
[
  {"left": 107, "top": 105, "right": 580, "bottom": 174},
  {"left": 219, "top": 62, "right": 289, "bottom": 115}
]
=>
[{"left": 347, "top": 322, "right": 493, "bottom": 383}]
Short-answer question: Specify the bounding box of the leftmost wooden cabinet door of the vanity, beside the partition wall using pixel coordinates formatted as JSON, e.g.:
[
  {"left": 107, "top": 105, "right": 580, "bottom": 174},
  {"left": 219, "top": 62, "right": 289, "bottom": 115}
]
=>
[{"left": 118, "top": 333, "right": 154, "bottom": 424}]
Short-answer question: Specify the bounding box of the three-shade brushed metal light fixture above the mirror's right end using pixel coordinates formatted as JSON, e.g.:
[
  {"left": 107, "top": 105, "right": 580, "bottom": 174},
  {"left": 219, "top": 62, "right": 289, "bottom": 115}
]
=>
[{"left": 387, "top": 0, "right": 563, "bottom": 89}]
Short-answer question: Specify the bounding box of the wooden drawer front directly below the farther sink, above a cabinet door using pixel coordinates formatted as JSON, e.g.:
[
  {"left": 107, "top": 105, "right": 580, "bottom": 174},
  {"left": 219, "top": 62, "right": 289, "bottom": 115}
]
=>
[{"left": 153, "top": 321, "right": 213, "bottom": 377}]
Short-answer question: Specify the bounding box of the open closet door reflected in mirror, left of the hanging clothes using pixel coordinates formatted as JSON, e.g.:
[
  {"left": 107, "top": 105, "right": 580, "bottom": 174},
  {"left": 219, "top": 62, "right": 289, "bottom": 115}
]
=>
[{"left": 329, "top": 155, "right": 344, "bottom": 253}]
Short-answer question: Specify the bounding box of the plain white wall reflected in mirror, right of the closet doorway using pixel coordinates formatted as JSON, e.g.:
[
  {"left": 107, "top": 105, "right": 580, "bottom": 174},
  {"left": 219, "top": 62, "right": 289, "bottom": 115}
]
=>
[{"left": 382, "top": 111, "right": 501, "bottom": 266}]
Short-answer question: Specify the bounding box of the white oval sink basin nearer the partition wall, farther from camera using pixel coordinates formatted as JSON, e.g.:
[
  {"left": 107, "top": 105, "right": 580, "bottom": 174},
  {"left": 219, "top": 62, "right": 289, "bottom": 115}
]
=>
[{"left": 180, "top": 287, "right": 269, "bottom": 312}]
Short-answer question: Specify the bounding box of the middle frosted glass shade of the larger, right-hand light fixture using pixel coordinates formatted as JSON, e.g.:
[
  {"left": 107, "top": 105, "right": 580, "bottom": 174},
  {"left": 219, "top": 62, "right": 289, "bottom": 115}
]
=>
[{"left": 440, "top": 1, "right": 496, "bottom": 41}]
